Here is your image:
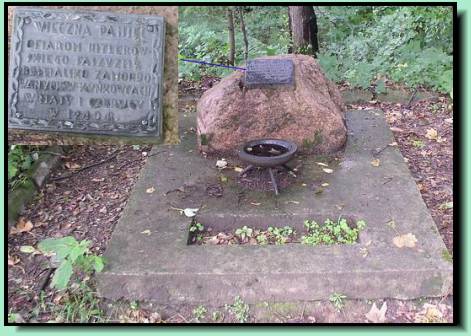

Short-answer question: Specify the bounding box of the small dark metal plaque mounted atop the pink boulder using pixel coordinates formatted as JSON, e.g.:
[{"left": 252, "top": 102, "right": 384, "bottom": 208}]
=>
[{"left": 245, "top": 59, "right": 294, "bottom": 88}]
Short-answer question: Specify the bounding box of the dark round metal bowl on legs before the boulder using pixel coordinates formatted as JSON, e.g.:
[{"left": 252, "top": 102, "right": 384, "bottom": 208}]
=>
[{"left": 238, "top": 139, "right": 298, "bottom": 167}]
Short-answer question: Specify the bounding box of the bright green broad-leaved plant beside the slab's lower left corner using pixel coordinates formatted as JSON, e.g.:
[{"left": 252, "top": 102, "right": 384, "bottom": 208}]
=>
[{"left": 38, "top": 236, "right": 105, "bottom": 290}]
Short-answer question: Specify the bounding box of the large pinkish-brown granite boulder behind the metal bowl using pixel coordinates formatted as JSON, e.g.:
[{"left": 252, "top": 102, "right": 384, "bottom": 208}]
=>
[{"left": 197, "top": 55, "right": 347, "bottom": 154}]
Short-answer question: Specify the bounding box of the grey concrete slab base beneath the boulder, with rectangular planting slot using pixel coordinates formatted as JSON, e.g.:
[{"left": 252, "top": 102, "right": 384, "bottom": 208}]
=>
[{"left": 98, "top": 110, "right": 452, "bottom": 304}]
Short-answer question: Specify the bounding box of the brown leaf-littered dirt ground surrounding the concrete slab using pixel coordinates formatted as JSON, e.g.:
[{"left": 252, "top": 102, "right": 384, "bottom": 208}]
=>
[{"left": 8, "top": 78, "right": 453, "bottom": 323}]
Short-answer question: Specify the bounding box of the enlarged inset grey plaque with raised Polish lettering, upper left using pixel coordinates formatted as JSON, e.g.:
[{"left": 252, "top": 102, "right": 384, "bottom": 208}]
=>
[{"left": 8, "top": 7, "right": 165, "bottom": 137}]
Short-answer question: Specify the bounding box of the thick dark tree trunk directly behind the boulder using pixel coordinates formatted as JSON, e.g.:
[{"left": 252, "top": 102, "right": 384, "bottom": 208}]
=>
[{"left": 289, "top": 6, "right": 319, "bottom": 56}]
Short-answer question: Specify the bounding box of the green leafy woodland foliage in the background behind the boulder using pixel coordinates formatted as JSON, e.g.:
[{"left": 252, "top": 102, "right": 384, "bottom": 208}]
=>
[{"left": 179, "top": 6, "right": 453, "bottom": 96}]
